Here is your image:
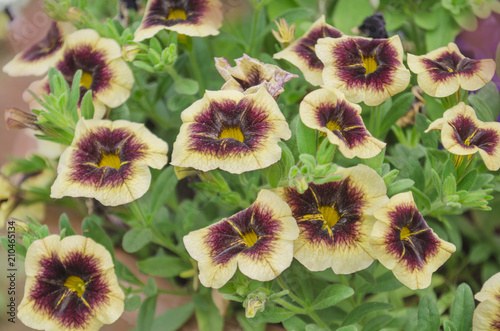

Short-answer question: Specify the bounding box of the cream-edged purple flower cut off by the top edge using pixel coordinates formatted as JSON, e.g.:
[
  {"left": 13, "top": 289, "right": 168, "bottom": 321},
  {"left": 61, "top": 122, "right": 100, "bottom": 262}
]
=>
[{"left": 134, "top": 0, "right": 222, "bottom": 42}]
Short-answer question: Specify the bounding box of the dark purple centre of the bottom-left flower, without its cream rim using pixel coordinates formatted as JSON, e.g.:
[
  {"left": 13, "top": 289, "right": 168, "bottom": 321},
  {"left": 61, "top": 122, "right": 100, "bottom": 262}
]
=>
[{"left": 29, "top": 252, "right": 110, "bottom": 329}]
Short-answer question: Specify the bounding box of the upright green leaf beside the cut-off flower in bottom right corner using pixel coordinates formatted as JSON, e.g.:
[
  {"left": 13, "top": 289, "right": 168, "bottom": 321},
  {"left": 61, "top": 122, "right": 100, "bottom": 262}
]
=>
[{"left": 450, "top": 283, "right": 475, "bottom": 331}]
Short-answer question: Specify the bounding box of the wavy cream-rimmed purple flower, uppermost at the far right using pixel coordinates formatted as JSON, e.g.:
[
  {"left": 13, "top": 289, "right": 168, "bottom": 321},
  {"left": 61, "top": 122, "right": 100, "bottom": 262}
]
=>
[{"left": 408, "top": 43, "right": 496, "bottom": 97}]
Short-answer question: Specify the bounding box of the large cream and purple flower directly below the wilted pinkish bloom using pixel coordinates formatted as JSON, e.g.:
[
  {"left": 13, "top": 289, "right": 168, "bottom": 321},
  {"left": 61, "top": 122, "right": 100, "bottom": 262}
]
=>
[{"left": 171, "top": 88, "right": 291, "bottom": 174}]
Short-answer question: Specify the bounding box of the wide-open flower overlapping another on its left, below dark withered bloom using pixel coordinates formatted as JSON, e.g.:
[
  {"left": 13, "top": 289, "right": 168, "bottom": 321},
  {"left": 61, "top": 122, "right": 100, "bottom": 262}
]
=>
[{"left": 316, "top": 36, "right": 410, "bottom": 106}]
